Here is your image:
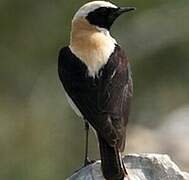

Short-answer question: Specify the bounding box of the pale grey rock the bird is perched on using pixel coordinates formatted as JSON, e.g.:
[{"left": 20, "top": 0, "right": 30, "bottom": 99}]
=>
[{"left": 67, "top": 154, "right": 189, "bottom": 180}]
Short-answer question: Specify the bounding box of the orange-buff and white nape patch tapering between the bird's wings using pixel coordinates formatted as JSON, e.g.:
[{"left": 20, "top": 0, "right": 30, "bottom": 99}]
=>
[{"left": 69, "top": 19, "right": 117, "bottom": 77}]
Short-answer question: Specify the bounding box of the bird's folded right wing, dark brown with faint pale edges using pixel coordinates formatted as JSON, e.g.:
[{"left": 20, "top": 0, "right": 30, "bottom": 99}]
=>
[{"left": 98, "top": 46, "right": 132, "bottom": 151}]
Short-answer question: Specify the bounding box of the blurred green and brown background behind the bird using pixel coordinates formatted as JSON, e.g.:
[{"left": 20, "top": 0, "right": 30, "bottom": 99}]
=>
[{"left": 0, "top": 0, "right": 189, "bottom": 180}]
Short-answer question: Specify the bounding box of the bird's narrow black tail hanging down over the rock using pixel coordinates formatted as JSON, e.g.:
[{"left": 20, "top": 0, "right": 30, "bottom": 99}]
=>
[{"left": 98, "top": 135, "right": 126, "bottom": 180}]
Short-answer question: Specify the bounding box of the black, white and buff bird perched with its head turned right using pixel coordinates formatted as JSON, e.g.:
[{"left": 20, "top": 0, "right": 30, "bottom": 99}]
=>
[{"left": 58, "top": 1, "right": 135, "bottom": 180}]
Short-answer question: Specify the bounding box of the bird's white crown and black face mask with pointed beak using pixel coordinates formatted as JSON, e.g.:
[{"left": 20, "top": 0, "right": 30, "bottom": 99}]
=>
[{"left": 72, "top": 1, "right": 135, "bottom": 30}]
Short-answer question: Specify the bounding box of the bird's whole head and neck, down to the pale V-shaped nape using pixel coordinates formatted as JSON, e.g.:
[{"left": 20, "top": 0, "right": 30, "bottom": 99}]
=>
[{"left": 69, "top": 1, "right": 135, "bottom": 77}]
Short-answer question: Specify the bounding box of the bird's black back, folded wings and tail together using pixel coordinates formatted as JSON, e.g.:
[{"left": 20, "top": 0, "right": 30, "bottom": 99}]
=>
[{"left": 58, "top": 45, "right": 132, "bottom": 180}]
